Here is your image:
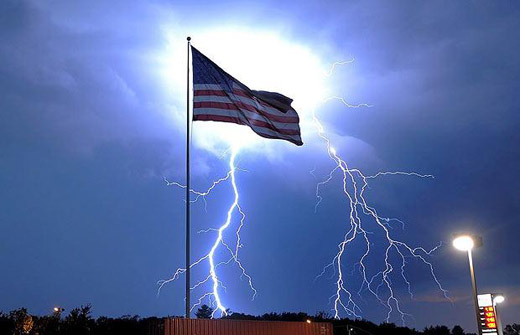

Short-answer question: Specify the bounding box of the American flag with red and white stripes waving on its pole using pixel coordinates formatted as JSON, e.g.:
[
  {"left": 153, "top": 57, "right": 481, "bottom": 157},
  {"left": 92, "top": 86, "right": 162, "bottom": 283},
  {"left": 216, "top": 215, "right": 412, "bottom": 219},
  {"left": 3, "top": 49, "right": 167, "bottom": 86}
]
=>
[{"left": 191, "top": 47, "right": 303, "bottom": 145}]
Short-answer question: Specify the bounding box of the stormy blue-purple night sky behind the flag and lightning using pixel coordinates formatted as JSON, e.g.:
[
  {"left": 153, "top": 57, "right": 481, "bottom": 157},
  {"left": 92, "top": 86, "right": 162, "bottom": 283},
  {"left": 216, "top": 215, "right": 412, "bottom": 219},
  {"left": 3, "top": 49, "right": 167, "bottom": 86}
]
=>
[{"left": 0, "top": 0, "right": 520, "bottom": 330}]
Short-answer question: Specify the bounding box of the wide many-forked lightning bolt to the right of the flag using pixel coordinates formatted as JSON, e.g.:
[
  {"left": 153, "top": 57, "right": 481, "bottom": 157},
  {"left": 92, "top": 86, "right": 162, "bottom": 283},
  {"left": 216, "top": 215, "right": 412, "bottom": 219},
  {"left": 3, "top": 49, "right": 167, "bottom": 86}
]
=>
[{"left": 311, "top": 60, "right": 449, "bottom": 324}]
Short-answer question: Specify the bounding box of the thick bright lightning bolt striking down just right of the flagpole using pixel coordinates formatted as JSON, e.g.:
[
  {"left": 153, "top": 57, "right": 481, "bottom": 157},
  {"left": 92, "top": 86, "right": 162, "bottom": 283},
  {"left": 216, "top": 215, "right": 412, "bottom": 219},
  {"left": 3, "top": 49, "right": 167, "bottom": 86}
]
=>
[{"left": 157, "top": 146, "right": 257, "bottom": 316}]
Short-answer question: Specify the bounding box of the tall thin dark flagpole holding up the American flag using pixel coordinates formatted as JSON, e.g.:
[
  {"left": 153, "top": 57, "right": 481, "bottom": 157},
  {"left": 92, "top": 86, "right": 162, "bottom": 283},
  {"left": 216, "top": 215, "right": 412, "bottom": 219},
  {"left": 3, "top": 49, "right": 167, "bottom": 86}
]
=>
[{"left": 186, "top": 36, "right": 191, "bottom": 319}]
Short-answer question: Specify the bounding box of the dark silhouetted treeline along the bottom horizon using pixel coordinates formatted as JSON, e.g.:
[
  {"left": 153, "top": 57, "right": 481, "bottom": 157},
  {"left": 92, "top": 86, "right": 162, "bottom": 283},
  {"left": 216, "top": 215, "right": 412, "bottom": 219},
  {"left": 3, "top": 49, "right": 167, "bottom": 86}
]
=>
[{"left": 0, "top": 305, "right": 520, "bottom": 335}]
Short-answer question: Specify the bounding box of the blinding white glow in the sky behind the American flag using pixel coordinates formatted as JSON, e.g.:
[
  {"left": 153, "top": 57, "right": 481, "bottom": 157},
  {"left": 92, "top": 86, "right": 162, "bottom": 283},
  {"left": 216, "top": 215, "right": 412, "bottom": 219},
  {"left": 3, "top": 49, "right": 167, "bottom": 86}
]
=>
[{"left": 160, "top": 27, "right": 328, "bottom": 153}]
